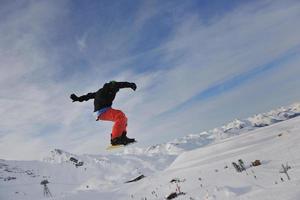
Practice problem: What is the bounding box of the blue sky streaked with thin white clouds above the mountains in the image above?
[0,0,300,159]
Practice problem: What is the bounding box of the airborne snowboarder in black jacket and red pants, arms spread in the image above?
[70,81,136,146]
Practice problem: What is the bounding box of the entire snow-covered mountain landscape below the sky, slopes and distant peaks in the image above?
[0,104,300,200]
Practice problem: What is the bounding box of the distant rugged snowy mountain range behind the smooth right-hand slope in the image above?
[139,103,300,155]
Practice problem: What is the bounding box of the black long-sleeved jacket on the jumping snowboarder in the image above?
[75,81,136,112]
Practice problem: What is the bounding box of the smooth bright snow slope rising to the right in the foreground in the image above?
[127,117,300,200]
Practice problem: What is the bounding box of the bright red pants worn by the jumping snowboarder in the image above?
[98,108,127,139]
